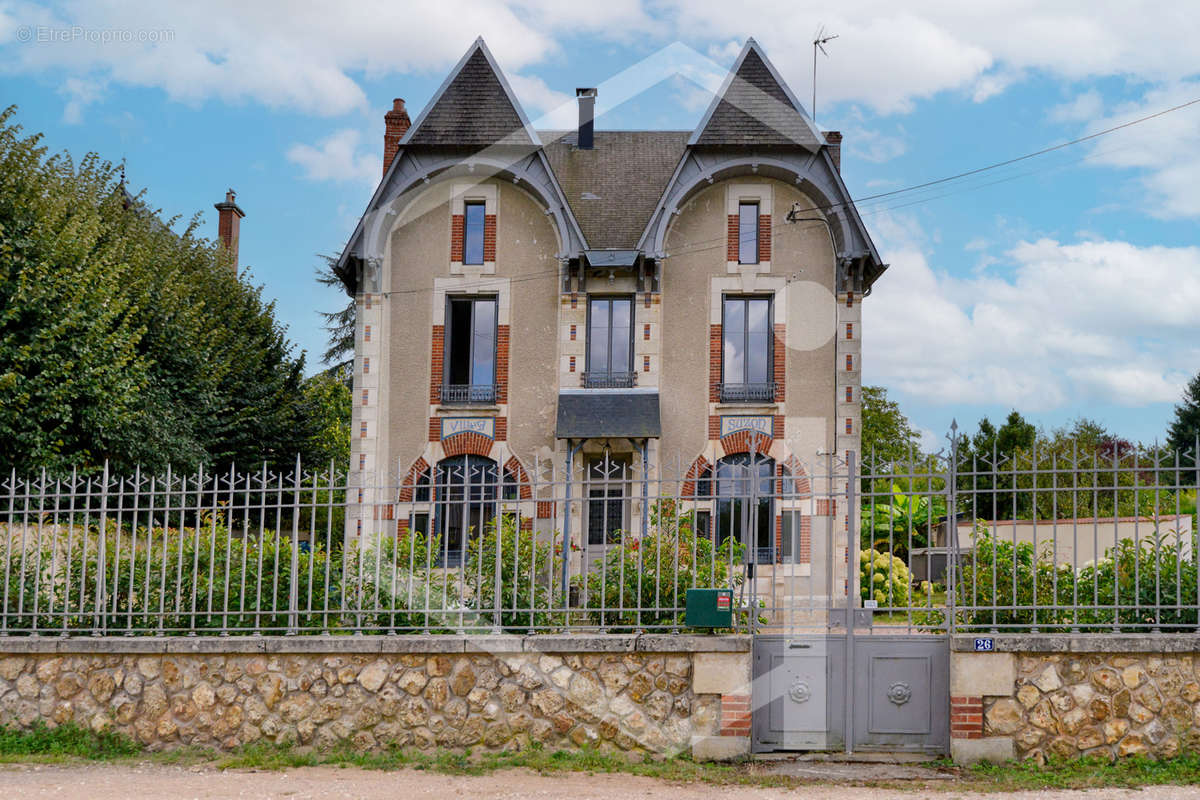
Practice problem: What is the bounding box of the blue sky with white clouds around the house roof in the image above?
[0,0,1200,449]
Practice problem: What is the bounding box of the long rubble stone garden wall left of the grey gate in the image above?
[0,636,750,758]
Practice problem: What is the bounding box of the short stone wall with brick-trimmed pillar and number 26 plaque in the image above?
[950,634,1200,762]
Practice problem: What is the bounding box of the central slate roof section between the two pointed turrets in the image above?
[539,131,691,249]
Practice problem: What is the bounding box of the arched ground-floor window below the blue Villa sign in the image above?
[436,455,499,566]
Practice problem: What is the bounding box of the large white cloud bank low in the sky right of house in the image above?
[864,212,1200,411]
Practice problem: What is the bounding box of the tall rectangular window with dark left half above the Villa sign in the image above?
[442,297,496,403]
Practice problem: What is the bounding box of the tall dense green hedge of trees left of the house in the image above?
[0,108,349,474]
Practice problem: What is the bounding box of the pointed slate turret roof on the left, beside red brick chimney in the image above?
[401,37,541,148]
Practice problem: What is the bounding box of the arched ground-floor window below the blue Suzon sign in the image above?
[713,453,775,563]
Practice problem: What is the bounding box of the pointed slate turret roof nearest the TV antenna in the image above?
[689,38,824,151]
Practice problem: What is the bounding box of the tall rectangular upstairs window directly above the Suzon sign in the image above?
[721,297,775,402]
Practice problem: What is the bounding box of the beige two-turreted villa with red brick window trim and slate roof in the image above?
[337,40,887,563]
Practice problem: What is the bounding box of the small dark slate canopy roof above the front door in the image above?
[554,389,662,439]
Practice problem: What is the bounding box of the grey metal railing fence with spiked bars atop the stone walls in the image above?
[0,435,1200,636]
